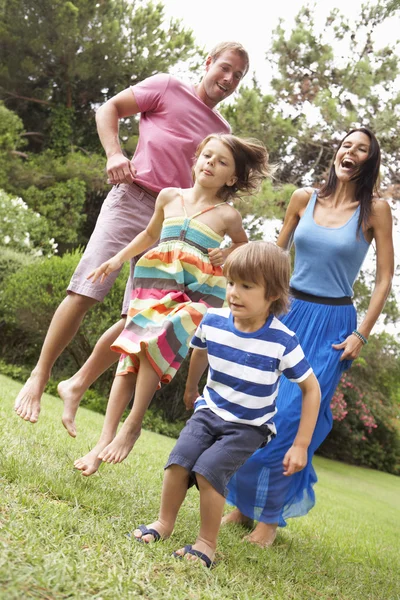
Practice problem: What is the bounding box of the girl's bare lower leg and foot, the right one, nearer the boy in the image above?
[99,352,160,463]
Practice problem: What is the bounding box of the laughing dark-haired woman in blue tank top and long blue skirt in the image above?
[224,128,394,546]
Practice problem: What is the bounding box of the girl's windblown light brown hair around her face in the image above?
[193,133,273,202]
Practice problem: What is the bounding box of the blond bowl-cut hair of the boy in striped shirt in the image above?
[223,242,290,316]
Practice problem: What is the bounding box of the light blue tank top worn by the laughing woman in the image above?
[290,190,369,298]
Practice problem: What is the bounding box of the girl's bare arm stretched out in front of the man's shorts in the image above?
[87,190,171,283]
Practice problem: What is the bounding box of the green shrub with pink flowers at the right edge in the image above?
[320,333,400,475]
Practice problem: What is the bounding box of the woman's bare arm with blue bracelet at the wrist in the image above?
[333,200,394,360]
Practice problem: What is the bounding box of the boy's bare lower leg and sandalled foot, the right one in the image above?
[176,473,225,562]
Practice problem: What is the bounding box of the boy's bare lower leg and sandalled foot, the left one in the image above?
[133,465,189,544]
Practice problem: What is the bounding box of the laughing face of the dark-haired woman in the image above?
[335,131,371,182]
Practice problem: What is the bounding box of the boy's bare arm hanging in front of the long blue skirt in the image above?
[283,373,321,475]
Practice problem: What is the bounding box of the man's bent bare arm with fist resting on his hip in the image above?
[96,88,140,185]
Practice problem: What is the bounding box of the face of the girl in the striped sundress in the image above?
[194,138,237,190]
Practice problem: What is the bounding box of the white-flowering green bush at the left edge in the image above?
[0,190,57,256]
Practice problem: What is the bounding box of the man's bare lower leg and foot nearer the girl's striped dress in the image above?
[57,319,125,437]
